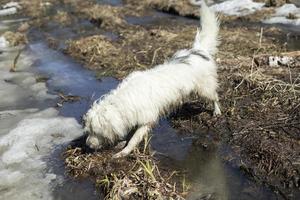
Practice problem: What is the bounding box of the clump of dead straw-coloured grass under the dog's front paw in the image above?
[64,141,188,200]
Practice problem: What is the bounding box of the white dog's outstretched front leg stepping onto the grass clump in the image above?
[113,125,150,158]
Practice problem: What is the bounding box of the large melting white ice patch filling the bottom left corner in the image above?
[0,108,82,200]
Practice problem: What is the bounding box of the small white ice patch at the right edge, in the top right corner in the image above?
[263,4,300,26]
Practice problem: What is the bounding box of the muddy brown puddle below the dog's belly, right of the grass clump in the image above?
[151,120,280,200]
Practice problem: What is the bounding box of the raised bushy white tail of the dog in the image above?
[193,0,219,55]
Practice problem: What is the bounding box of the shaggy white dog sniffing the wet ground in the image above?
[84,1,221,158]
